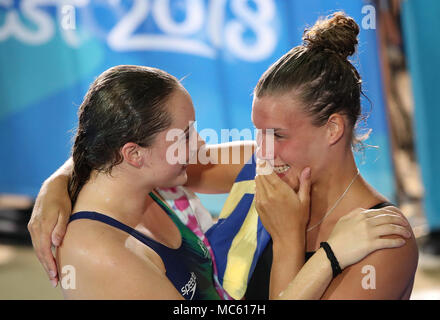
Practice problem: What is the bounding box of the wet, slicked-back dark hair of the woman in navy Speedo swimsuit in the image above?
[69,65,180,203]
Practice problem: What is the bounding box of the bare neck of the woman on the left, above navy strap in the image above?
[74,170,153,228]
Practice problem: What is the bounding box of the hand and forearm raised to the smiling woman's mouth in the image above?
[255,165,311,299]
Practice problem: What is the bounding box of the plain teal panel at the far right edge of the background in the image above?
[402,0,440,230]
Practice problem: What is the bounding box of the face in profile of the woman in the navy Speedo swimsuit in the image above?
[141,87,196,188]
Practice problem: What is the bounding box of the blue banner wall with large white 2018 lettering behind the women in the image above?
[0,0,394,215]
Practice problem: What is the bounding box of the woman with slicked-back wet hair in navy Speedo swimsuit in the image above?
[57,66,227,299]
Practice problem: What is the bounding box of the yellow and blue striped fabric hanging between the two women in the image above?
[205,155,270,300]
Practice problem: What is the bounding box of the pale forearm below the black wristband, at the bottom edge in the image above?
[277,248,333,300]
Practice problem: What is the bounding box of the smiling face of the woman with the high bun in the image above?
[252,94,329,190]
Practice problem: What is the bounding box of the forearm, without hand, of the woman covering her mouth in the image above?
[269,231,305,299]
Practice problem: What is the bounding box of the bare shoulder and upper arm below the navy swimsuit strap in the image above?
[57,221,180,299]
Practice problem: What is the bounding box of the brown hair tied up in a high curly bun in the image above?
[254,12,363,145]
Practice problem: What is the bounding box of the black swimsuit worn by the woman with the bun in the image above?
[245,202,394,300]
